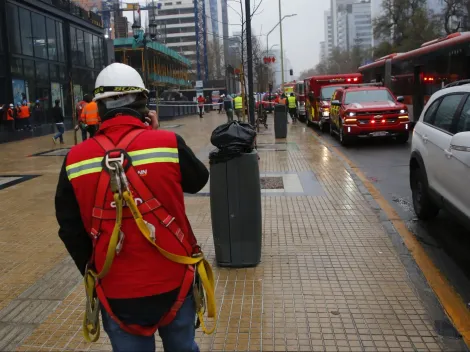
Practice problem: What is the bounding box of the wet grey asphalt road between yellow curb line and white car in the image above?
[312,127,470,308]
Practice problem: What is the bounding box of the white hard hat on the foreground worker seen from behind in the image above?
[93,63,148,101]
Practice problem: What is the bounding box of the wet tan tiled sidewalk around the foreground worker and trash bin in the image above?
[0,113,466,352]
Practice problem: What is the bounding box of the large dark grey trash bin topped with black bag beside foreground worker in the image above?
[210,122,262,268]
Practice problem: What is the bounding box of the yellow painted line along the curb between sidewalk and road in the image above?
[314,133,470,347]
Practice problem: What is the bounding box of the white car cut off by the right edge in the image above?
[410,80,470,227]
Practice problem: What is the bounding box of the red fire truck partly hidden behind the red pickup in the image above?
[304,73,362,132]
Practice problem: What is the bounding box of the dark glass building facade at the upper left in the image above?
[0,0,107,142]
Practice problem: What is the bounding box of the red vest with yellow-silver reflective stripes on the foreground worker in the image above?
[66,116,199,336]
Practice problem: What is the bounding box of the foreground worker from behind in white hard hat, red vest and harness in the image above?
[55,63,216,352]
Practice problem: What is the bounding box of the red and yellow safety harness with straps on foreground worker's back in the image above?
[83,129,216,342]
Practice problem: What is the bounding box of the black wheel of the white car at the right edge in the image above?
[411,167,439,220]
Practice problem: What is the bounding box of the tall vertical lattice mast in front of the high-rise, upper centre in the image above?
[194,0,209,81]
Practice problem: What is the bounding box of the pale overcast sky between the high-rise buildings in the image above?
[228,0,330,75]
